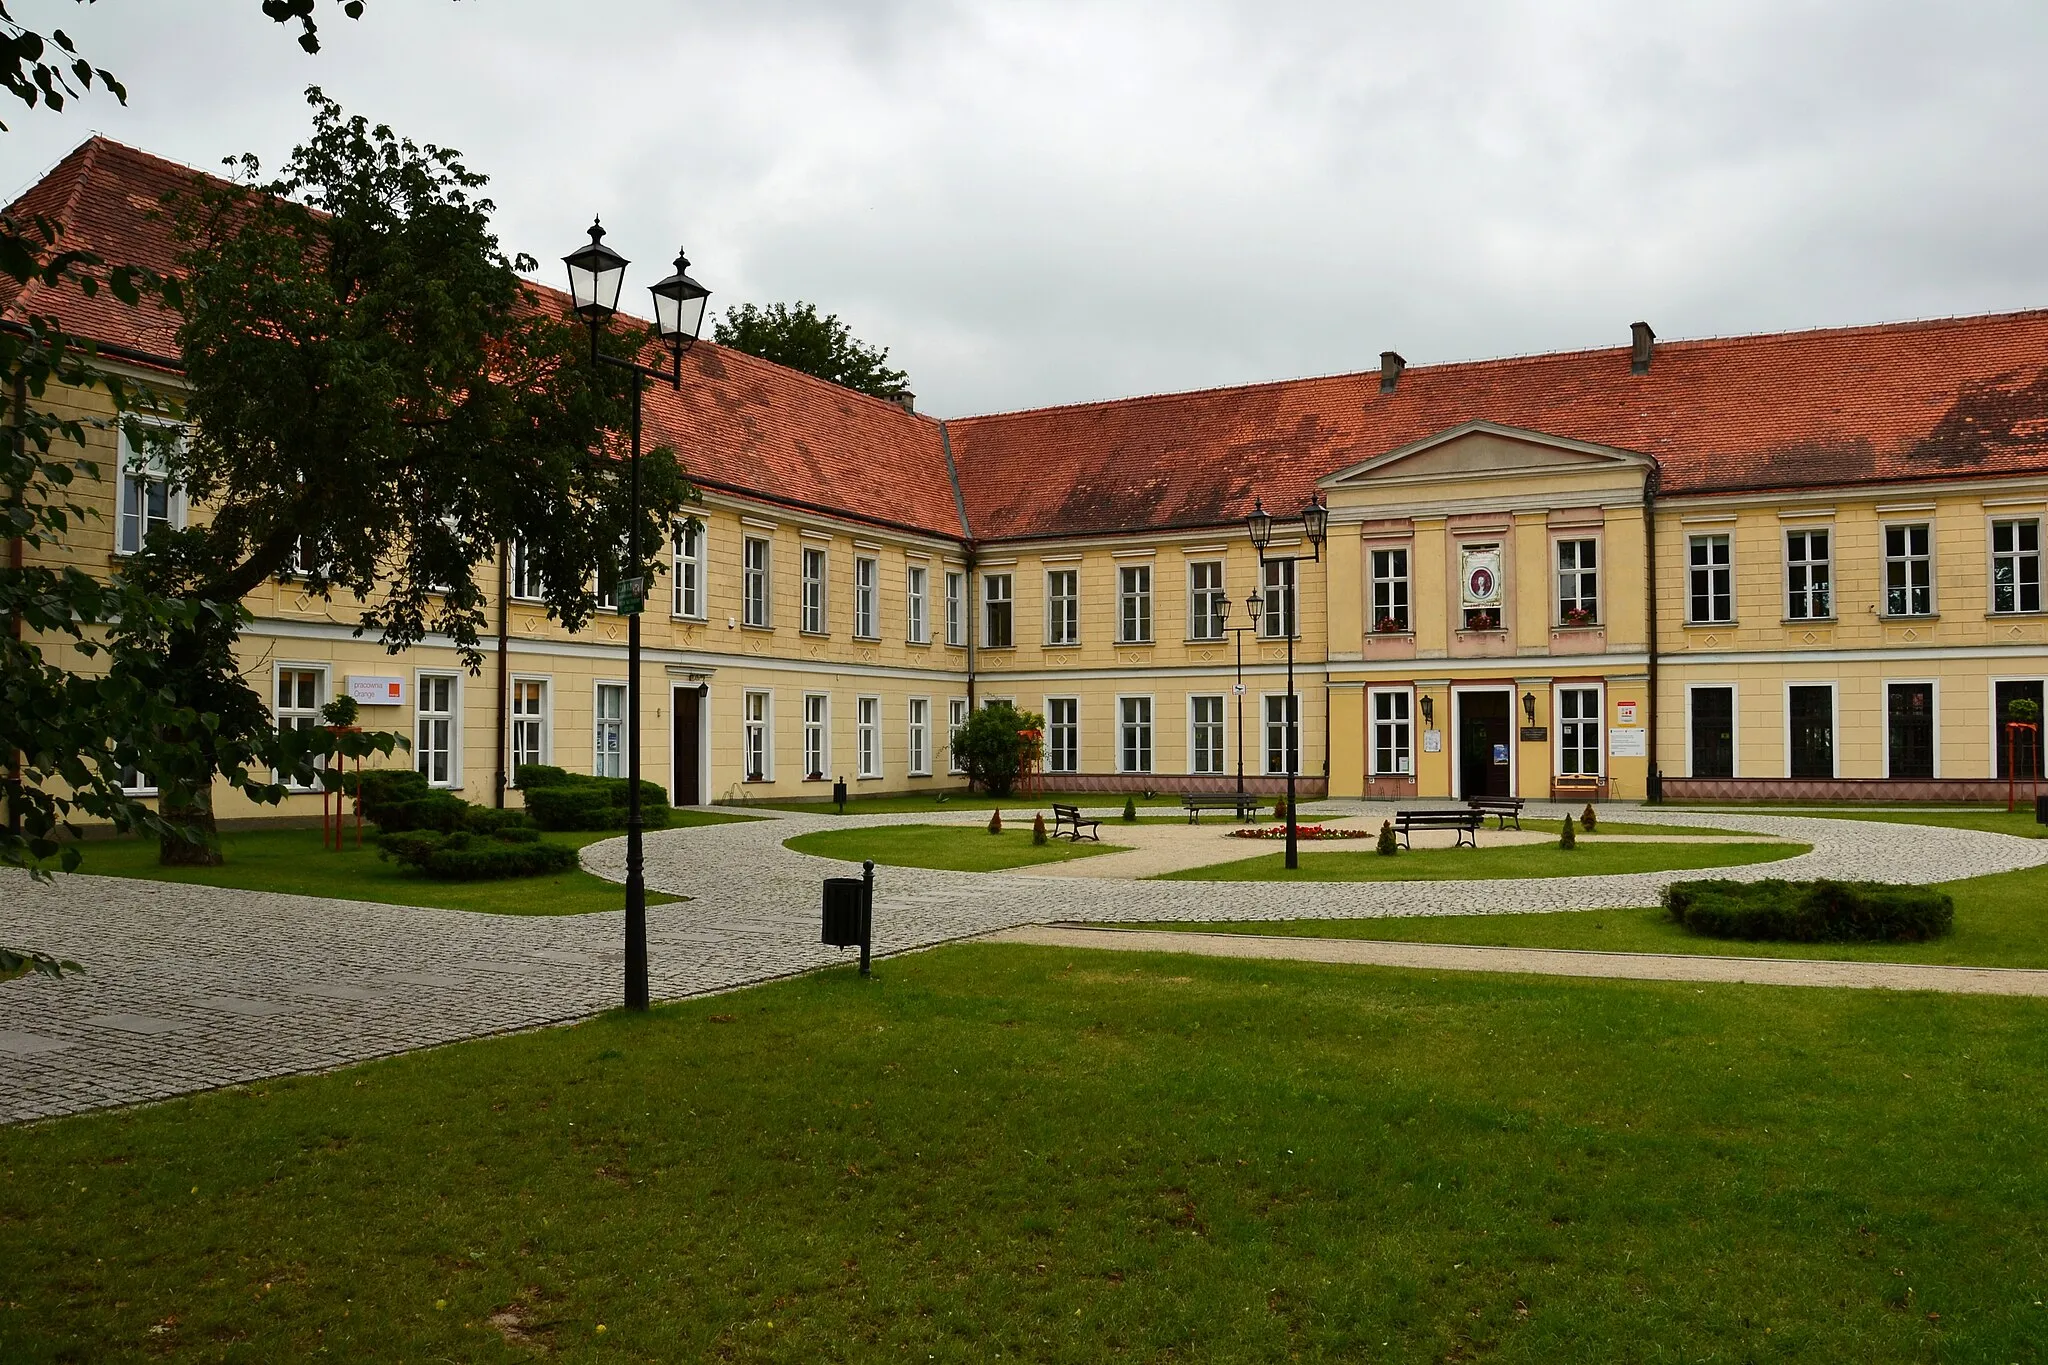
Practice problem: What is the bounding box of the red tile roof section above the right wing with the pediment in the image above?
[948,309,2048,540]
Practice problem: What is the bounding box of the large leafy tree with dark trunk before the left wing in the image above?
[137,88,692,862]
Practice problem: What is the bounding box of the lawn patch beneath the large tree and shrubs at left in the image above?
[59,810,757,915]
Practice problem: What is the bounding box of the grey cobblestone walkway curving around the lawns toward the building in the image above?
[0,802,2048,1121]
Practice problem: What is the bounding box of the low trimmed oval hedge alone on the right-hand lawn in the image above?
[1663,878,1956,943]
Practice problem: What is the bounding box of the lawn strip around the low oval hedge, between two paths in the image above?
[1155,860,2048,968]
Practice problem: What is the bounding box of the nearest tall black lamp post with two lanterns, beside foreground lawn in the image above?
[561,221,711,1009]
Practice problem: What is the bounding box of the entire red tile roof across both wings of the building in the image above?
[16,137,2048,540]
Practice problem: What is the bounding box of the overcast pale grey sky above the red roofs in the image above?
[0,0,2048,415]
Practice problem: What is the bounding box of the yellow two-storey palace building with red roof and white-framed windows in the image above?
[0,139,2048,817]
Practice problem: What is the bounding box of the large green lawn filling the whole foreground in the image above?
[0,945,2048,1365]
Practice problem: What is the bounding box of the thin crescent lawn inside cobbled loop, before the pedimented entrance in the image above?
[1151,835,1810,882]
